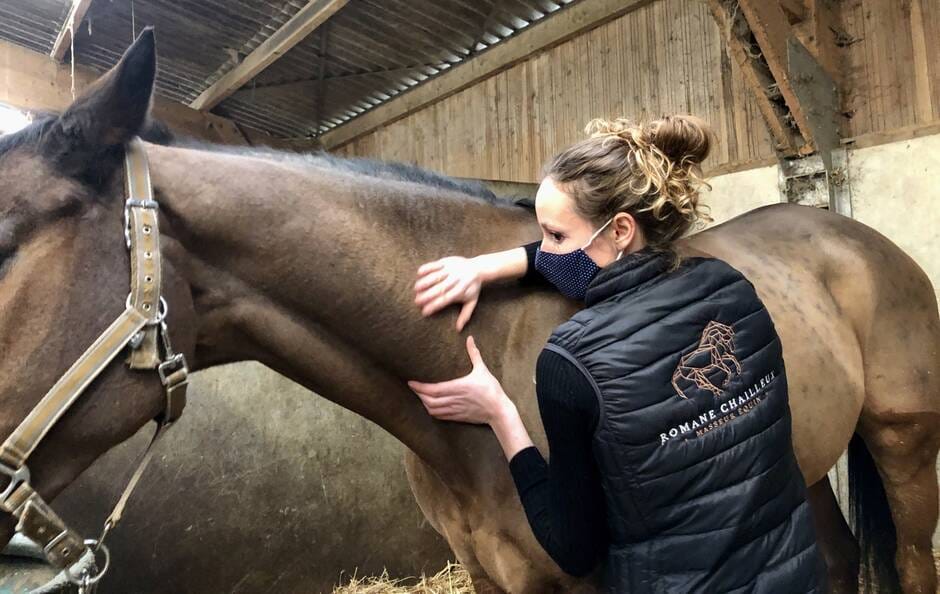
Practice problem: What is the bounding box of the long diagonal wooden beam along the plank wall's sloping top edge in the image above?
[320,0,655,150]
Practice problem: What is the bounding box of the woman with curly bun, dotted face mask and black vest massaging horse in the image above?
[409,116,825,594]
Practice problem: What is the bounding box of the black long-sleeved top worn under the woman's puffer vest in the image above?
[509,242,607,576]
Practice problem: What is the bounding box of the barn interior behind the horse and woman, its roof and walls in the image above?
[0,0,940,593]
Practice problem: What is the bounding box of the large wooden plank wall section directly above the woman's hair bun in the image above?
[337,0,773,182]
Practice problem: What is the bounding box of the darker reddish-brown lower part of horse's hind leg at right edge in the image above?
[860,412,940,594]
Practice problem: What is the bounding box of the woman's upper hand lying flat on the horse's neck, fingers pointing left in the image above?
[415,256,483,332]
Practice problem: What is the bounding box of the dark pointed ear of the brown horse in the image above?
[43,27,157,174]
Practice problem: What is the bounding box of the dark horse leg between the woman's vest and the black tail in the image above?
[807,476,859,594]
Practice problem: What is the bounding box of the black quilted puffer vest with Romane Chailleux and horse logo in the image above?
[546,250,825,594]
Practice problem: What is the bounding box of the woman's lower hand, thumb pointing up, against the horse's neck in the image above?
[408,336,512,425]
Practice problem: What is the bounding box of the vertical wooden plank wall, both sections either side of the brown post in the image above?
[337,0,940,182]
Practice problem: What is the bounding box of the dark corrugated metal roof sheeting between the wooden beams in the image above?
[0,0,576,138]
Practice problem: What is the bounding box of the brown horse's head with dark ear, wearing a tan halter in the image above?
[0,30,194,580]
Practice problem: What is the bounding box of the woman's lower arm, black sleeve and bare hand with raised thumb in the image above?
[408,337,607,576]
